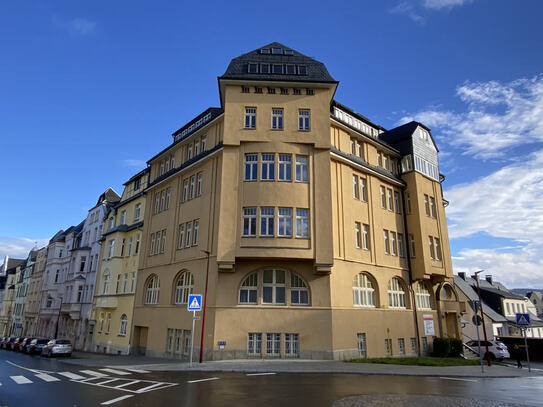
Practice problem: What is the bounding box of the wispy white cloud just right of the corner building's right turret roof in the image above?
[401,75,543,159]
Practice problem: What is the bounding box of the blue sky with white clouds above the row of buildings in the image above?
[0,0,543,288]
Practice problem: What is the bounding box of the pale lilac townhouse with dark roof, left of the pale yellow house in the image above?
[59,188,120,350]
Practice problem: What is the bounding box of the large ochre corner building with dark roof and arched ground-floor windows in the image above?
[132,43,461,359]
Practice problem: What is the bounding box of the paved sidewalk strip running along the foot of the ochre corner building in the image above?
[59,352,543,378]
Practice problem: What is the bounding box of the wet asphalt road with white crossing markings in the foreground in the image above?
[0,350,543,407]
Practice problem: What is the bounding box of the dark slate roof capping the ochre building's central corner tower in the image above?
[219,42,338,84]
